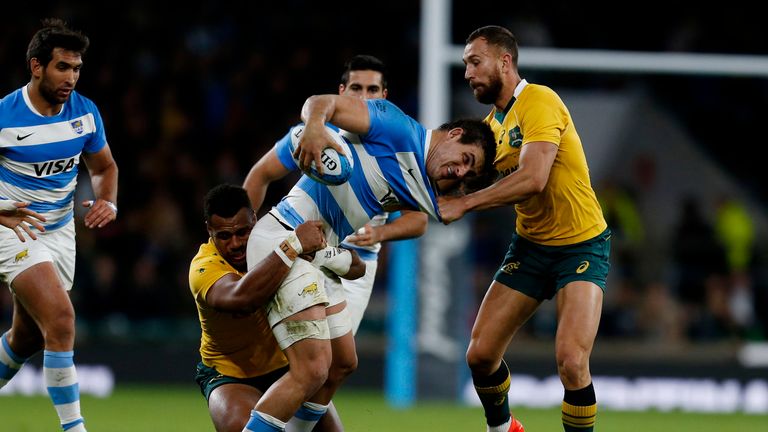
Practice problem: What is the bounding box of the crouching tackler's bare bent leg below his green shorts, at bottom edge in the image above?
[208,383,262,432]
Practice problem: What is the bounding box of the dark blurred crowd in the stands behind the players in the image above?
[0,0,768,354]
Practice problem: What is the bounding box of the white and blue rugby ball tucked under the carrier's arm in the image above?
[291,125,355,186]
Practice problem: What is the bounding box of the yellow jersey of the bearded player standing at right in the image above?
[485,80,607,246]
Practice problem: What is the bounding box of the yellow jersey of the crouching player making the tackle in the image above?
[189,239,288,378]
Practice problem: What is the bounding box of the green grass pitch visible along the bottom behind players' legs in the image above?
[0,386,768,432]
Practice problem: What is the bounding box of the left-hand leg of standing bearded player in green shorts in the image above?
[467,281,539,432]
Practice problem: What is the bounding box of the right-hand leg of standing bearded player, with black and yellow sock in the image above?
[555,281,603,432]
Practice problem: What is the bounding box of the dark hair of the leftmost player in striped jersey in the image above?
[27,18,91,72]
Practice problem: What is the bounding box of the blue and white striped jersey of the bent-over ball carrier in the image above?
[275,99,440,246]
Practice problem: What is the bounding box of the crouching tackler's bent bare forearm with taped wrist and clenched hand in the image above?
[205,221,326,312]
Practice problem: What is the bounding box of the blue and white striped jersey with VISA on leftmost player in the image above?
[0,86,107,231]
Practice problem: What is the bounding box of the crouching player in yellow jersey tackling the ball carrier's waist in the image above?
[189,185,365,432]
